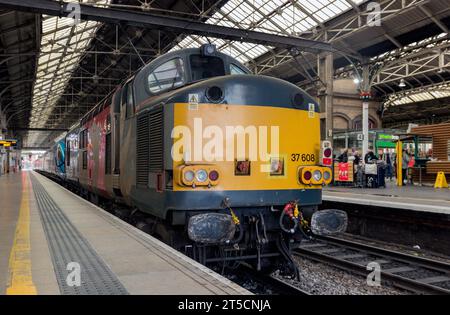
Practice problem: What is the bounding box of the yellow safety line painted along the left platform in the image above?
[6,172,37,295]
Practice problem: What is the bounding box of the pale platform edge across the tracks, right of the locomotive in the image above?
[322,181,450,214]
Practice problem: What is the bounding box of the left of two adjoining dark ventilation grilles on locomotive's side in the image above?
[136,113,150,186]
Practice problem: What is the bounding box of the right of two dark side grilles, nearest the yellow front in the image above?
[149,107,164,173]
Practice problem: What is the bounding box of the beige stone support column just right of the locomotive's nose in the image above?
[318,53,334,141]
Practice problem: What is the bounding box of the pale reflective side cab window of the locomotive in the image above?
[148,58,184,94]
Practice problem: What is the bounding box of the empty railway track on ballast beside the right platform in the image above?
[294,236,450,294]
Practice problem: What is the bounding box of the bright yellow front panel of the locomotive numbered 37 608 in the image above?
[173,103,331,194]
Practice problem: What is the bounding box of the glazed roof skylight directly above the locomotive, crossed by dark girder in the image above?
[172,0,356,63]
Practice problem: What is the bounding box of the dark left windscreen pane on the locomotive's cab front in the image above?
[189,55,225,81]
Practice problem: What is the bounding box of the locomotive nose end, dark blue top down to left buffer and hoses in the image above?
[167,76,346,270]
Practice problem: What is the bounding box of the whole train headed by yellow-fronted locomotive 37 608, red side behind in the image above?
[42,45,346,272]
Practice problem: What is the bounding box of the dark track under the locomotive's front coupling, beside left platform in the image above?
[235,264,311,295]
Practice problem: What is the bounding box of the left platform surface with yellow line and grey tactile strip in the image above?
[0,171,250,295]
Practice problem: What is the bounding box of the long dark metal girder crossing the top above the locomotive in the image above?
[0,0,334,53]
